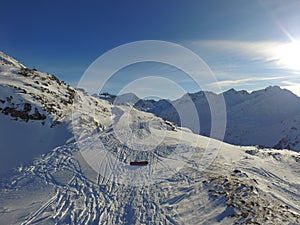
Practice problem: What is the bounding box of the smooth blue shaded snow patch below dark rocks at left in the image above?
[0,114,71,175]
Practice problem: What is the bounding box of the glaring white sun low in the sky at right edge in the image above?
[275,41,300,70]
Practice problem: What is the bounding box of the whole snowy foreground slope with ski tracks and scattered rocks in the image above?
[0,53,300,225]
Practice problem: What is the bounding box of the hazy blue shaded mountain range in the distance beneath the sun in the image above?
[136,86,300,151]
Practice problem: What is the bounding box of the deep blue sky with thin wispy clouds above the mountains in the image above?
[0,0,300,98]
